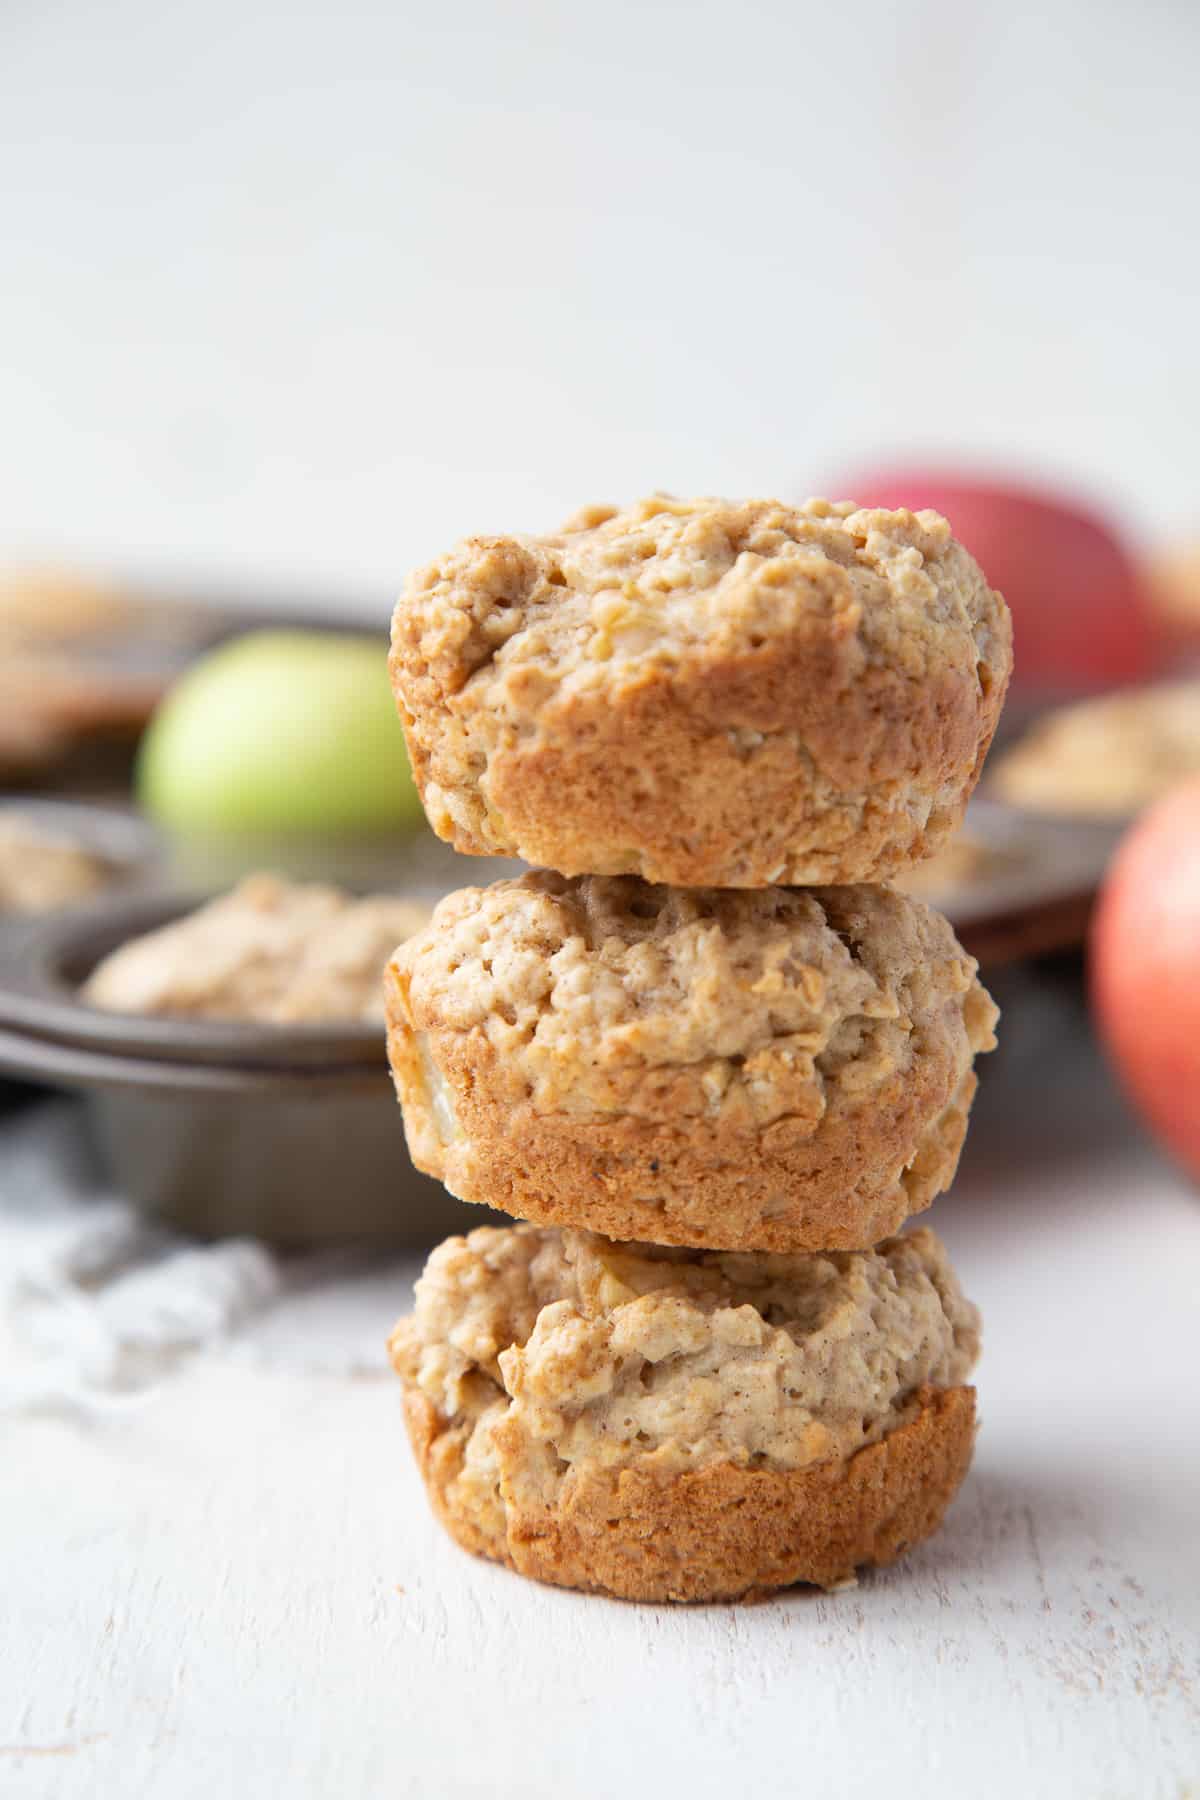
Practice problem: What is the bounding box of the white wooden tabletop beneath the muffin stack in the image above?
[0,972,1200,1800]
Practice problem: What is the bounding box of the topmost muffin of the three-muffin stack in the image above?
[390,495,1011,887]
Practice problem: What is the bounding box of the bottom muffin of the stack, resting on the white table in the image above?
[390,1226,979,1600]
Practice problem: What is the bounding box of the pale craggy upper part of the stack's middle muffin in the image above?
[396,871,997,1129]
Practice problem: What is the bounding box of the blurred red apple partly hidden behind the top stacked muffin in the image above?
[842,466,1155,691]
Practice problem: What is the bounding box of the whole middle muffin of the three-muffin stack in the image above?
[387,871,997,1251]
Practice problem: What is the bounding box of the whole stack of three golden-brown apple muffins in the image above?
[389,497,1011,1600]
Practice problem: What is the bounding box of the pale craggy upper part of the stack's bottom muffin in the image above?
[392,1226,979,1498]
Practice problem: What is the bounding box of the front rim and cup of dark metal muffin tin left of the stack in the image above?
[0,849,491,1246]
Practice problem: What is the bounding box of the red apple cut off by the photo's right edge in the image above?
[1090,779,1200,1179]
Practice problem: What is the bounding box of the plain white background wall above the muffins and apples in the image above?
[0,0,1200,610]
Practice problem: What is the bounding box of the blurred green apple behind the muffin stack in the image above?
[137,630,423,837]
